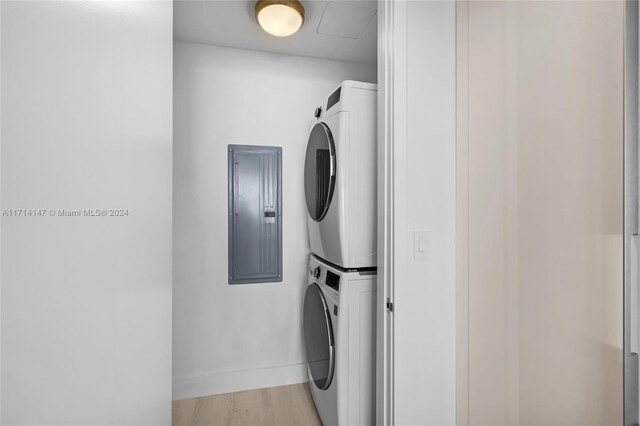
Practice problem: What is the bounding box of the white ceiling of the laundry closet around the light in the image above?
[173,0,377,64]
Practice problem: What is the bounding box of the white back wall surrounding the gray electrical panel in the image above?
[173,42,376,399]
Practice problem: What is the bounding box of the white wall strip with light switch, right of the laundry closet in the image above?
[378,1,456,426]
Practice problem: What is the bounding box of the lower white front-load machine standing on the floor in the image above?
[304,255,376,426]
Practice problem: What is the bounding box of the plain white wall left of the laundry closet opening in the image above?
[0,1,173,425]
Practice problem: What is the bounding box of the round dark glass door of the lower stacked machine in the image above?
[304,284,335,390]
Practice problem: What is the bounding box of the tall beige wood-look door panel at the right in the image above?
[458,1,624,425]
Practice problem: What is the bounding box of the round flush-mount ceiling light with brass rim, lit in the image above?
[256,0,304,37]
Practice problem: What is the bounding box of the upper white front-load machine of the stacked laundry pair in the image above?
[304,81,378,268]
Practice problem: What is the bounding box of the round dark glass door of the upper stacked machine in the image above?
[304,123,336,222]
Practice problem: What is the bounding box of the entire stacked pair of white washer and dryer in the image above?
[304,81,377,426]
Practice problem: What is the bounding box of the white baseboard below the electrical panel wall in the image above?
[173,363,307,400]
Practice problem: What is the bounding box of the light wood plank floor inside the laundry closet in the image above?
[172,383,322,426]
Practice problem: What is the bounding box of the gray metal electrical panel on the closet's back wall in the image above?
[228,145,282,284]
